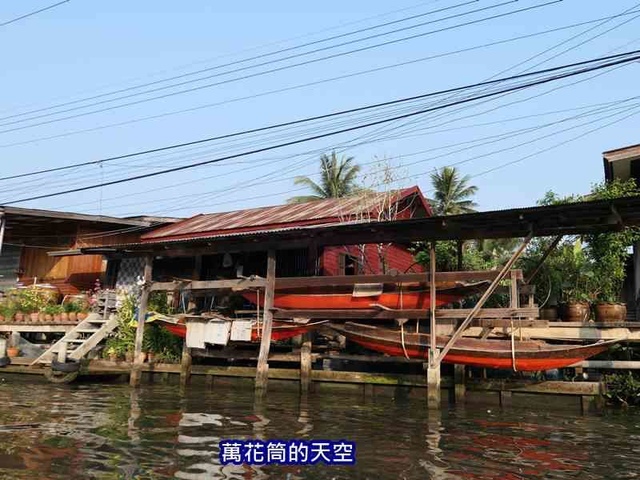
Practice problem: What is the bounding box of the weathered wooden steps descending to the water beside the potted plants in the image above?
[31,293,118,366]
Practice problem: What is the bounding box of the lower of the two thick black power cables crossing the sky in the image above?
[5,51,640,205]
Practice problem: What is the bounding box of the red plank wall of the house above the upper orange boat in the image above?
[320,244,424,275]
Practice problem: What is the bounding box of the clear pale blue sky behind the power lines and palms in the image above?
[0,0,640,217]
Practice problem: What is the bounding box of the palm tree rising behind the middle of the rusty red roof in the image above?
[287,151,360,203]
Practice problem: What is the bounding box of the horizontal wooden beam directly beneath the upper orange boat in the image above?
[273,307,540,320]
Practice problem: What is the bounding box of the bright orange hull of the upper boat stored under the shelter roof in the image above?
[242,282,484,310]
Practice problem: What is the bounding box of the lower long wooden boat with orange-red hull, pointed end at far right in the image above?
[331,322,620,371]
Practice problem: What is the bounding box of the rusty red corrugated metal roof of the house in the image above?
[141,186,431,243]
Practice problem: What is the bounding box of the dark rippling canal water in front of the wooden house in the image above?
[0,377,640,480]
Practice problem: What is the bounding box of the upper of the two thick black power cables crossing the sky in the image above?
[0,45,640,181]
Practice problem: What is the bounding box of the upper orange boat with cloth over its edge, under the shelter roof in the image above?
[242,282,487,310]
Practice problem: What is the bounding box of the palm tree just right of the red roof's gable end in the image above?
[429,167,478,215]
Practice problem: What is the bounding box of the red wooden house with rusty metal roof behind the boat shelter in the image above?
[118,186,431,285]
